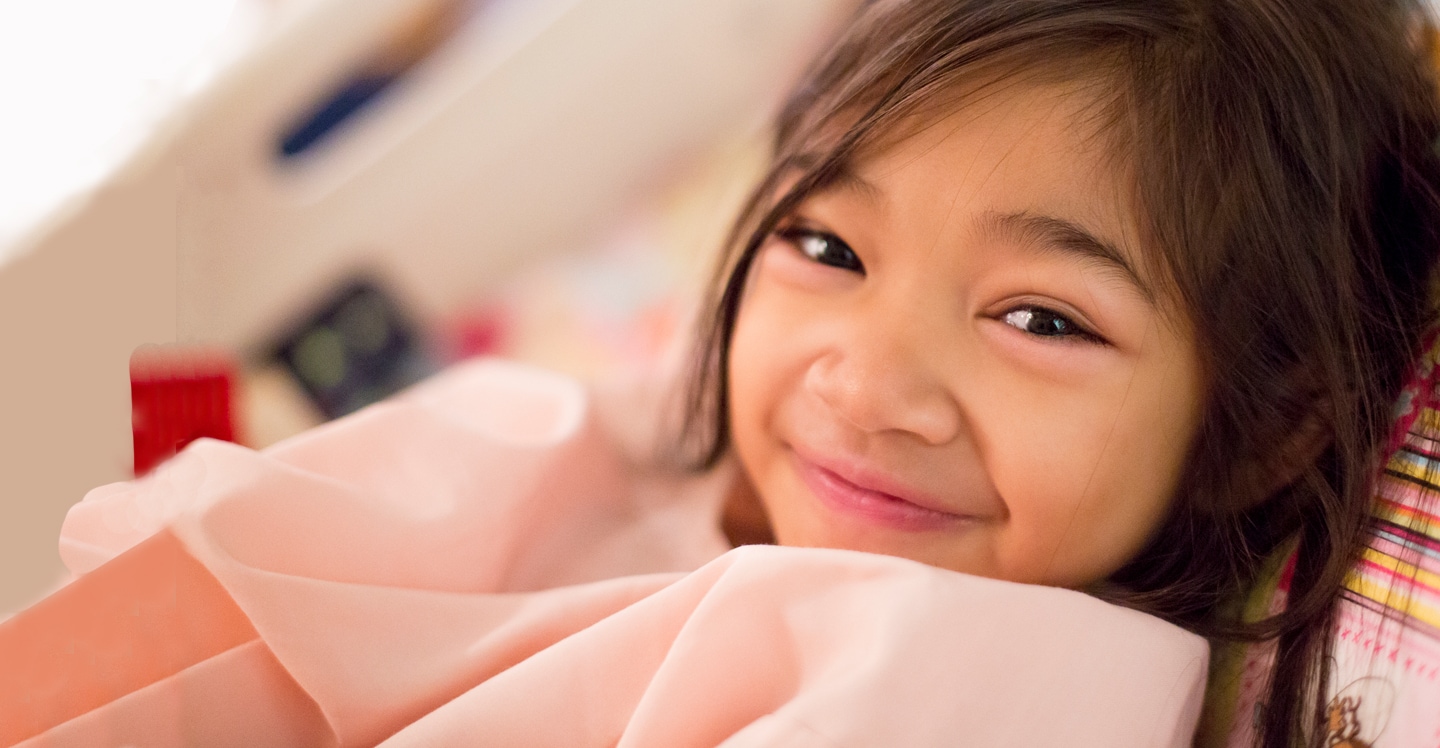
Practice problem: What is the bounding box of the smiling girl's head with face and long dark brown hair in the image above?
[676,0,1440,747]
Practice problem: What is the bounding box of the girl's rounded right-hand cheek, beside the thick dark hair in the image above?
[989,350,1198,587]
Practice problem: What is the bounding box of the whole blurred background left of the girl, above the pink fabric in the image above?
[0,0,855,618]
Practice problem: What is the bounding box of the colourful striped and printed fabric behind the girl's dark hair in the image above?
[1195,336,1440,748]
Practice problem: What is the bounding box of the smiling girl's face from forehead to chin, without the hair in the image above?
[729,85,1202,587]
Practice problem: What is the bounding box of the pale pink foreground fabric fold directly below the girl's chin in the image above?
[383,546,1207,748]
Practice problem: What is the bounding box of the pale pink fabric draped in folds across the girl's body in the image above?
[30,360,1208,748]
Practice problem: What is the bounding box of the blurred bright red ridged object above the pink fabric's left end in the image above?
[130,346,236,476]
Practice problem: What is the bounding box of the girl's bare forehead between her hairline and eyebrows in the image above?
[827,81,1188,321]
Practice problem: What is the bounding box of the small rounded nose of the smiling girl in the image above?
[805,317,963,445]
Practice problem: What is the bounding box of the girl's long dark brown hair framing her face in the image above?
[685,0,1440,747]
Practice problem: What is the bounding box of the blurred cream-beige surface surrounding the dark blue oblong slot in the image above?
[0,0,850,614]
